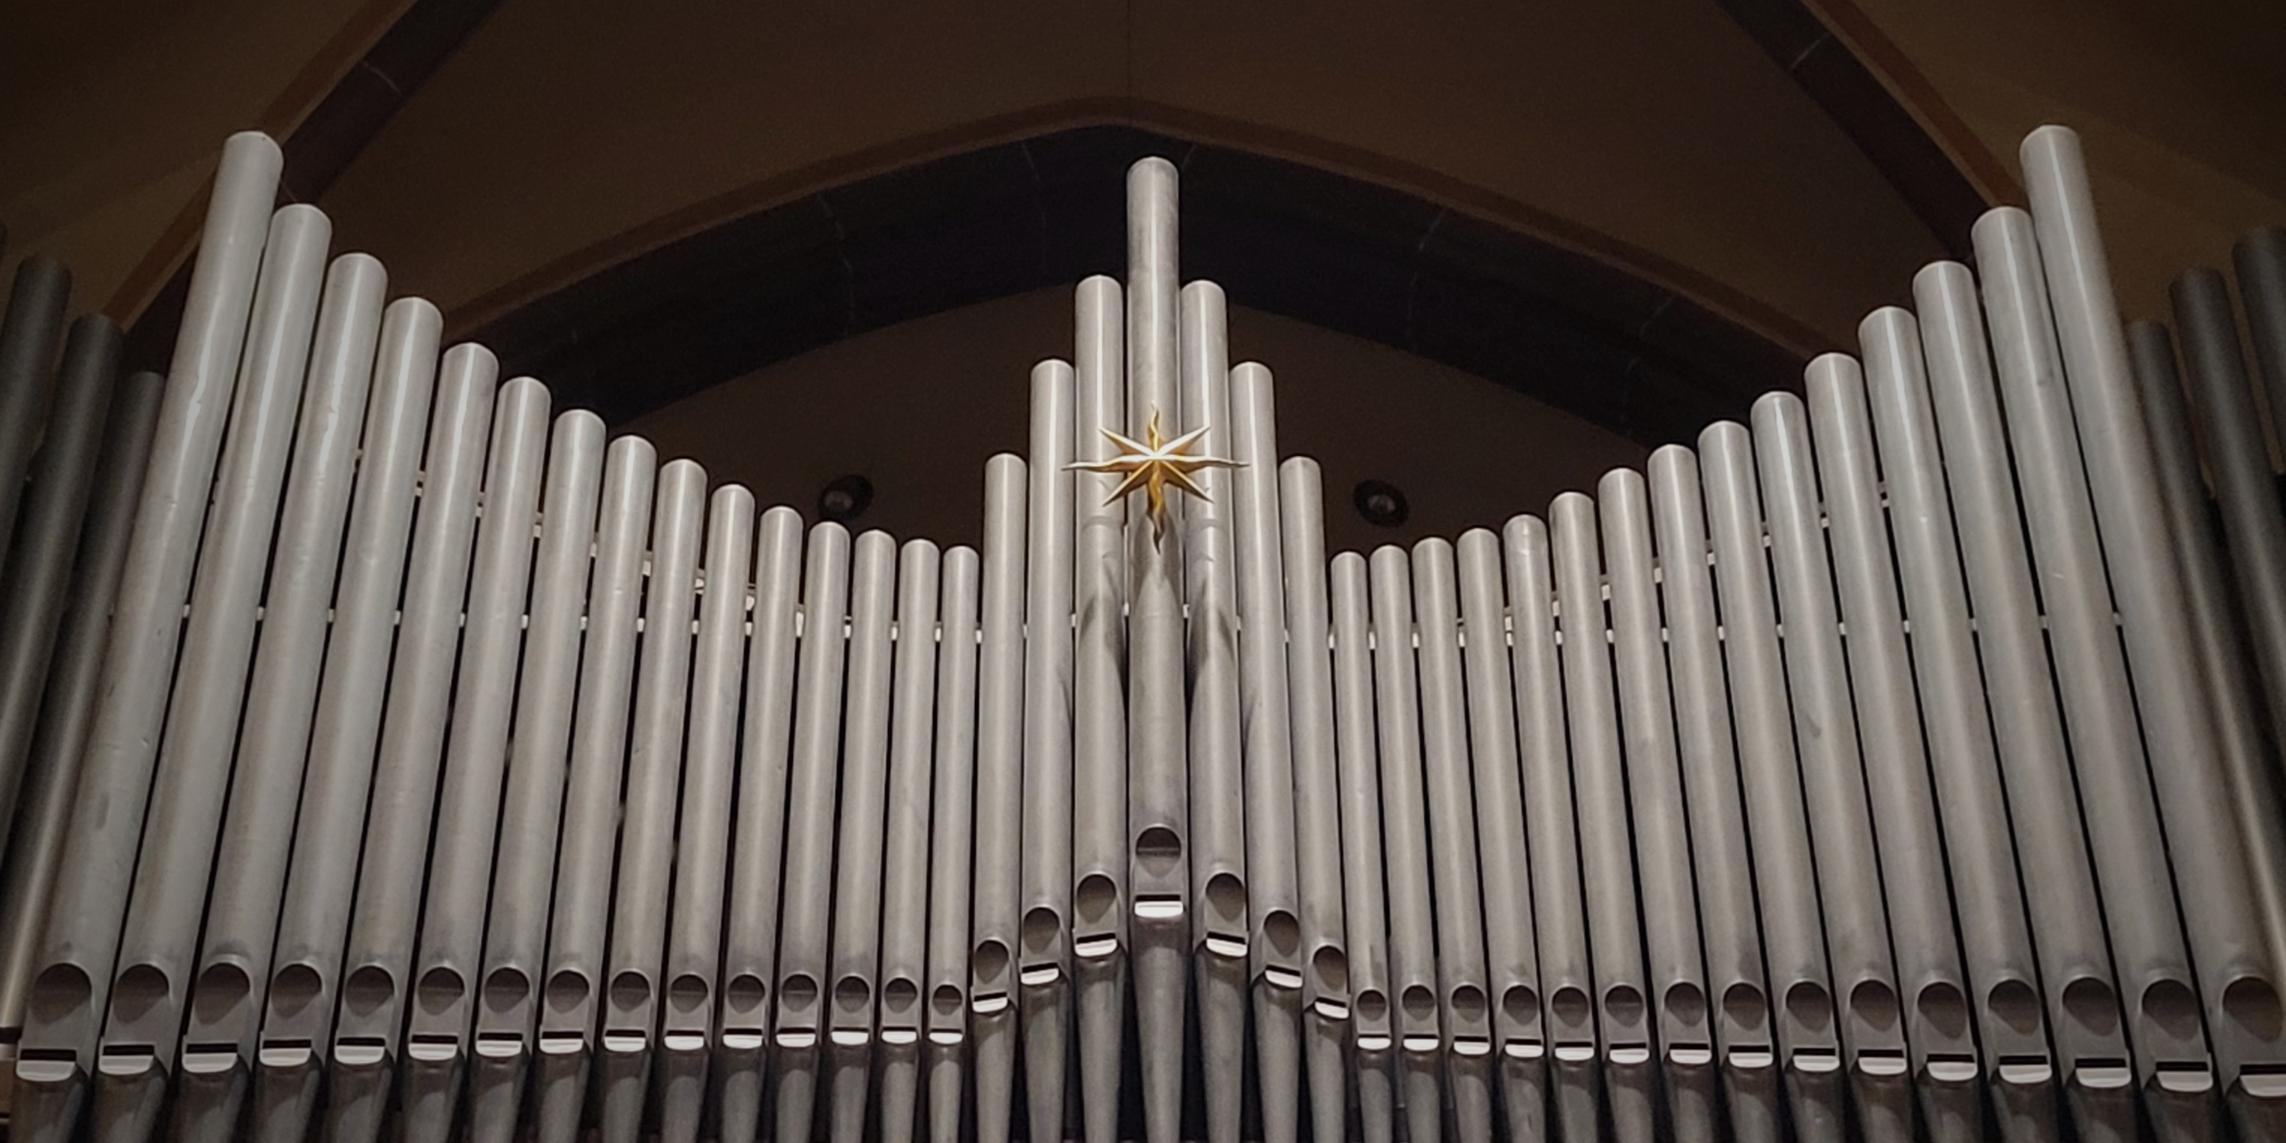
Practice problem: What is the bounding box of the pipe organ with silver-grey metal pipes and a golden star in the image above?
[0,128,2286,1143]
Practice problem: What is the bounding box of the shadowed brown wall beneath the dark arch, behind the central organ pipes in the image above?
[629,288,1644,551]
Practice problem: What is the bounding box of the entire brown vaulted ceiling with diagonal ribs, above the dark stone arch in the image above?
[0,0,2286,436]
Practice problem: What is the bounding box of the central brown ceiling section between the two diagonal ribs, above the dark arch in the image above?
[325,0,1936,347]
